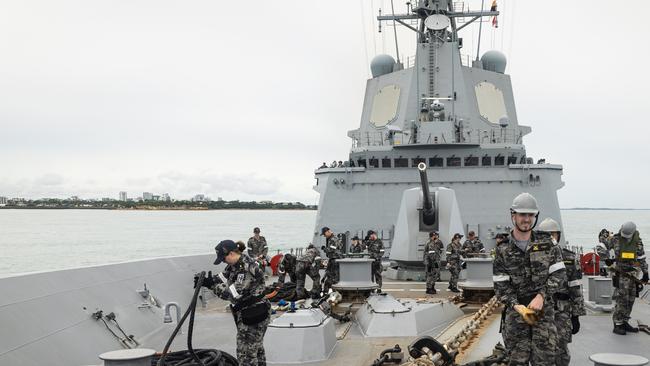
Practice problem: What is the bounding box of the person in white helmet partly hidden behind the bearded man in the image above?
[539,217,587,366]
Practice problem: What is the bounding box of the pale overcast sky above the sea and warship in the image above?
[0,0,650,208]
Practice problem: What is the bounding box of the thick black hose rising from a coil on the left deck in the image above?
[151,271,239,366]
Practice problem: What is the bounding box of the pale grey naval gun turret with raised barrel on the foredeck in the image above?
[386,163,464,280]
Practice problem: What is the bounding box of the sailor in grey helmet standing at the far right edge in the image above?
[606,221,648,335]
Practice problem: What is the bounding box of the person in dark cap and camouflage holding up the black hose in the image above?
[208,240,271,365]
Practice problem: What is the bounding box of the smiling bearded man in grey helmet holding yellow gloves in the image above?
[493,193,566,365]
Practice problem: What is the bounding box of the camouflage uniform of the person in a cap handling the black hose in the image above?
[215,254,271,365]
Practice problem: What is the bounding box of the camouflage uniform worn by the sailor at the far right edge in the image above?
[611,231,648,325]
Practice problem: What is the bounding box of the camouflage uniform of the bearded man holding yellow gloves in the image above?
[493,233,566,365]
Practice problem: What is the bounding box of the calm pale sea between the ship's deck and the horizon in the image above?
[0,210,650,277]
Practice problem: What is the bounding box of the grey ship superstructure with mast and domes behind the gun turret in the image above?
[314,0,564,255]
